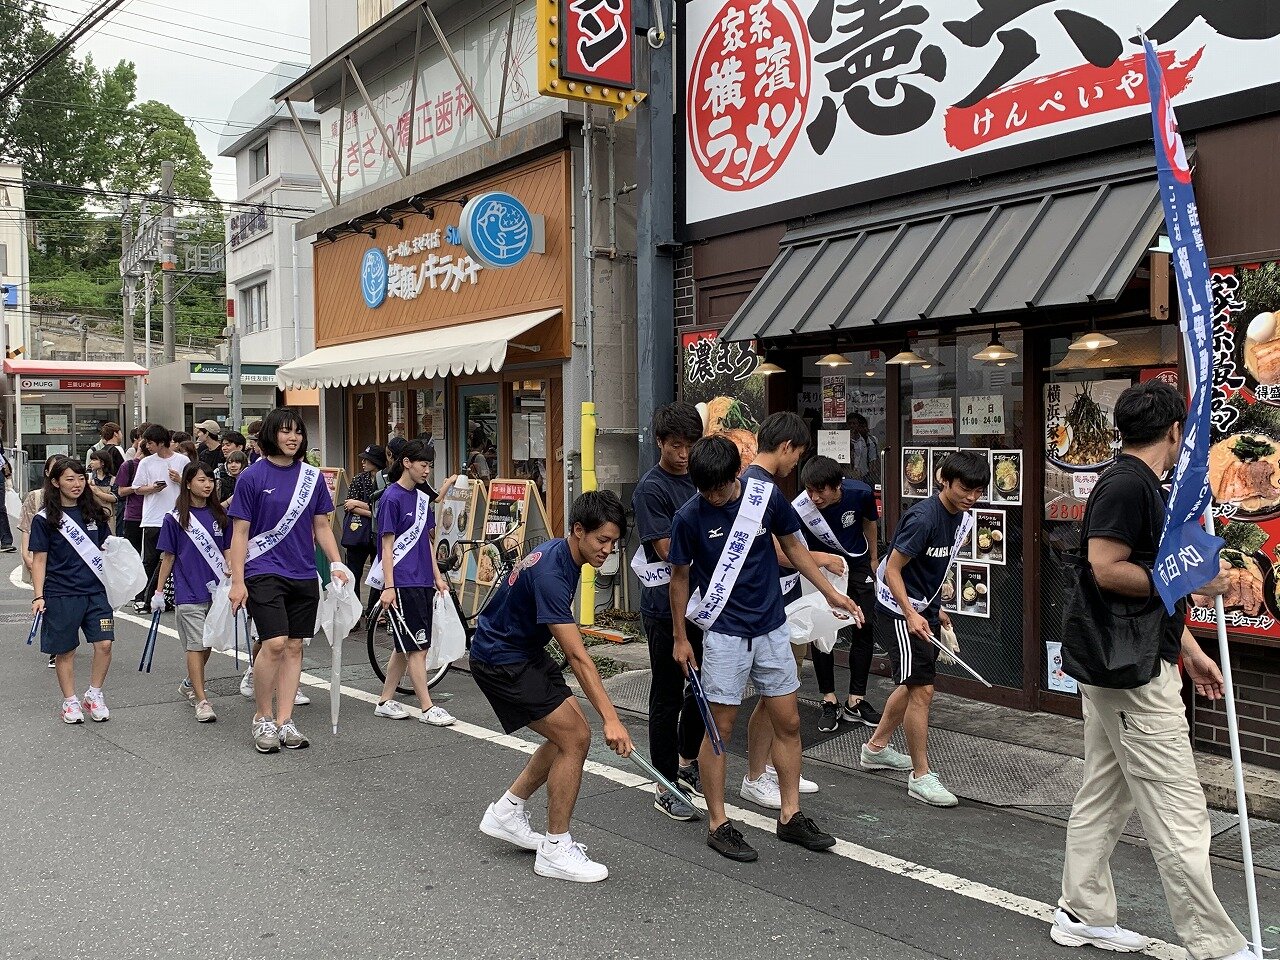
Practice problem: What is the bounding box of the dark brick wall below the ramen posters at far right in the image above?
[1196,641,1280,769]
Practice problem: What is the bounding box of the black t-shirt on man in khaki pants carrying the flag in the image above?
[1080,453,1187,663]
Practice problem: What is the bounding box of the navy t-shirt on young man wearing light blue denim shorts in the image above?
[667,467,800,637]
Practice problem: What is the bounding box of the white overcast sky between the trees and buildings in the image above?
[45,0,312,200]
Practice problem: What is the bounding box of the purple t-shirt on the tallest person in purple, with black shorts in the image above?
[227,457,333,580]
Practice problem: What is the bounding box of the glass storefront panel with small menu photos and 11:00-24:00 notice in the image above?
[901,333,1024,689]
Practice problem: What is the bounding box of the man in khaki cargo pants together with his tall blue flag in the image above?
[1050,38,1262,960]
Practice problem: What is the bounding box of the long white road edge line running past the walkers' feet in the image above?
[9,567,1187,960]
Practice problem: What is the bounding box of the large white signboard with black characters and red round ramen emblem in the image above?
[686,0,1280,231]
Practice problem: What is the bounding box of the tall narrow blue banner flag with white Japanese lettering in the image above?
[1142,37,1222,613]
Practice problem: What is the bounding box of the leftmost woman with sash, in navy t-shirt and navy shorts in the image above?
[29,457,115,723]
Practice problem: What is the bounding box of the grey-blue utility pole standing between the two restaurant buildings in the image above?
[634,0,676,474]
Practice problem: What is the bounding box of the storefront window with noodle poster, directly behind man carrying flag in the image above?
[1033,325,1179,694]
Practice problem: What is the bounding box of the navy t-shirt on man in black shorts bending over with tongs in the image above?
[471,540,579,666]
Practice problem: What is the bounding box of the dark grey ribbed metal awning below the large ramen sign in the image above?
[721,155,1164,340]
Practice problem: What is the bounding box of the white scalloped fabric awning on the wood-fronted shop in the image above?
[275,310,561,389]
